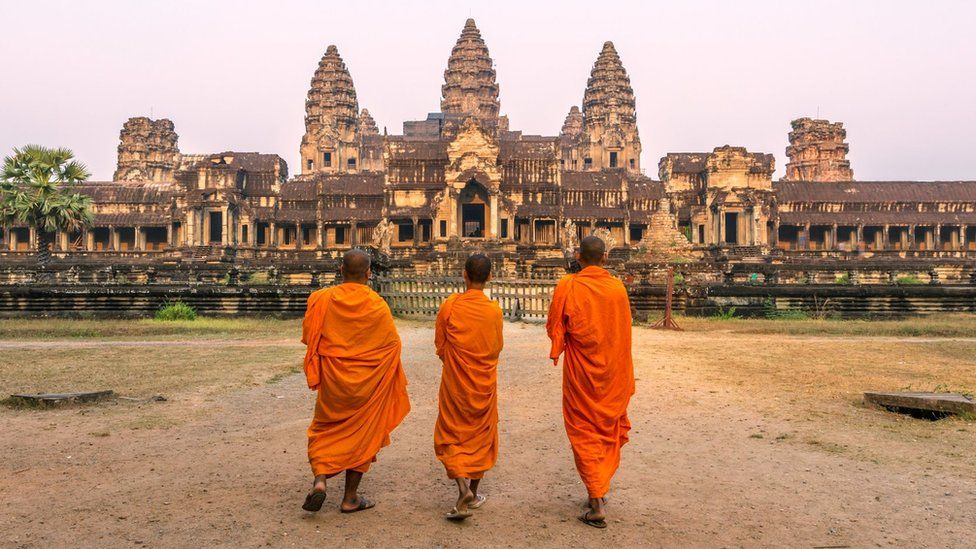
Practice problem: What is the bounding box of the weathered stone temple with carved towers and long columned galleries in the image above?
[0,19,976,277]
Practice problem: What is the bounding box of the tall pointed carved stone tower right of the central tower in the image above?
[579,42,641,172]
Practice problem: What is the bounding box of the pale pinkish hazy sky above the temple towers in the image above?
[0,0,976,180]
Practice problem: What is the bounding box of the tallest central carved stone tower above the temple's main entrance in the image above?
[441,19,499,131]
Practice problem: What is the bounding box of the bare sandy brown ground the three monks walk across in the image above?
[0,322,976,547]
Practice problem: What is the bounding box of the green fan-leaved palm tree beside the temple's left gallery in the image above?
[0,145,94,266]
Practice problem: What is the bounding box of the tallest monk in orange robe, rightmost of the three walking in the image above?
[546,236,634,528]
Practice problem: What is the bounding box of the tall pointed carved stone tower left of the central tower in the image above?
[300,46,360,175]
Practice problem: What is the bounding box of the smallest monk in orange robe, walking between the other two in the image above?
[434,254,502,521]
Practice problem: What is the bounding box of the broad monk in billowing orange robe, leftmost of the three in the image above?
[302,250,410,513]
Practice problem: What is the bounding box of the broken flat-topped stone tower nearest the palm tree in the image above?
[112,116,180,182]
